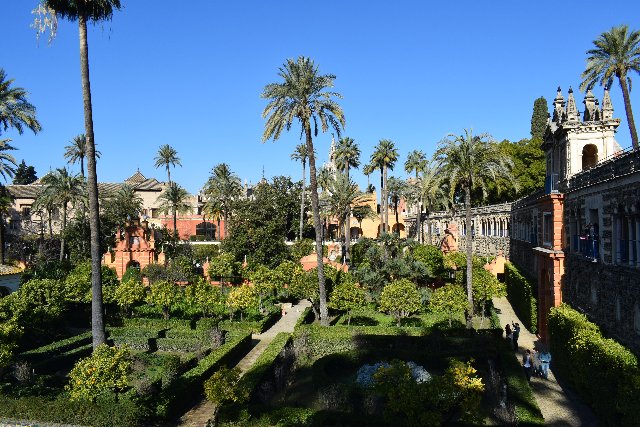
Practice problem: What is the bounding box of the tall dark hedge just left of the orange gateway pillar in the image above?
[504,262,538,334]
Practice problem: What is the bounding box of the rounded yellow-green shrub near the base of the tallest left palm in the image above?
[66,344,131,402]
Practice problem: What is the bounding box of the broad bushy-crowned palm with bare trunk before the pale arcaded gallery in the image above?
[434,129,515,328]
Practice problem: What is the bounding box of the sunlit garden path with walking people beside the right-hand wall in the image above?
[493,297,598,427]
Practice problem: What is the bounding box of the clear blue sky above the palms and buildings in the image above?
[0,0,640,192]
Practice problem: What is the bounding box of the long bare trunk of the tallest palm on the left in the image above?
[78,16,107,349]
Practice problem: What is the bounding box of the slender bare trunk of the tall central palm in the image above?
[304,122,329,326]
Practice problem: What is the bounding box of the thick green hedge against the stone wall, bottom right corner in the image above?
[548,304,640,426]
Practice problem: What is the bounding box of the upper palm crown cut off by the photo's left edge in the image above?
[0,68,42,135]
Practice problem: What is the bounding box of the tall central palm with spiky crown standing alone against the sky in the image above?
[262,56,345,326]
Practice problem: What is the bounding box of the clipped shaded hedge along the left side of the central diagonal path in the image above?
[157,333,251,418]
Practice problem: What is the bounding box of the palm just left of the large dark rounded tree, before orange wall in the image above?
[204,163,242,238]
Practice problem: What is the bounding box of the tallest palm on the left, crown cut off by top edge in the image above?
[41,0,121,349]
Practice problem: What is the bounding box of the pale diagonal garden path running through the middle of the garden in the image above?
[175,300,311,427]
